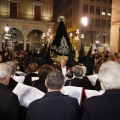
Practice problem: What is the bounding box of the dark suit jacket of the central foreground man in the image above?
[26,91,80,120]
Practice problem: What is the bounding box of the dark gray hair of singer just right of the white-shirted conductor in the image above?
[73,65,83,77]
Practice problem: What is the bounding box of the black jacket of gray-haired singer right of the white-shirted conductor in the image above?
[65,77,92,89]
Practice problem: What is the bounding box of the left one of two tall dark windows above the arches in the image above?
[10,2,17,18]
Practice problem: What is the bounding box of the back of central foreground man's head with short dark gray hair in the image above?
[46,70,64,90]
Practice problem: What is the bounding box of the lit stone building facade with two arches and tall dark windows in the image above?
[0,0,54,50]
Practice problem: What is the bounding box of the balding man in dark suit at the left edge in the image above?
[0,63,20,120]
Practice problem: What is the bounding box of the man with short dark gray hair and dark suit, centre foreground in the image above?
[26,71,80,120]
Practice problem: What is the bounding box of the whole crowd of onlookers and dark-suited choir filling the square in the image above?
[0,50,120,120]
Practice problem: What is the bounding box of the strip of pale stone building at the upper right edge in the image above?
[110,0,120,53]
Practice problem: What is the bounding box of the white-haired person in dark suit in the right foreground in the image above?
[82,61,120,120]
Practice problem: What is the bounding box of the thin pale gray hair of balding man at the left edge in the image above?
[0,63,11,81]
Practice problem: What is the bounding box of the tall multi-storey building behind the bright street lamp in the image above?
[53,0,112,51]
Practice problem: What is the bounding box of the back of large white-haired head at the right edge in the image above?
[98,61,120,90]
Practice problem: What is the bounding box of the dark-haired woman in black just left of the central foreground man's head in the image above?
[32,64,54,93]
